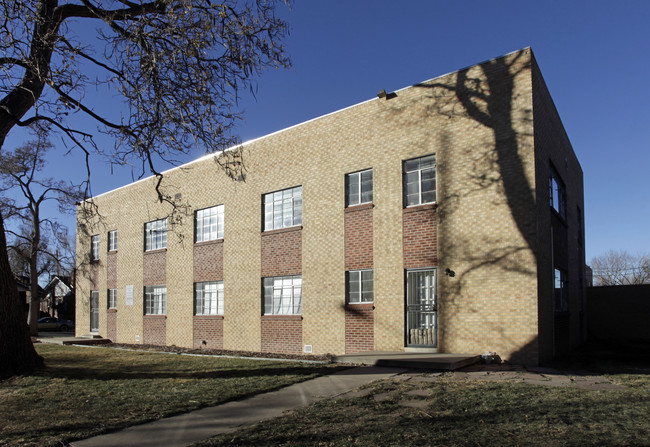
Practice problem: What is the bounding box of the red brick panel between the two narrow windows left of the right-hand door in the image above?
[345,204,373,270]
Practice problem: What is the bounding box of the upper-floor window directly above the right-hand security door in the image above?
[403,154,436,206]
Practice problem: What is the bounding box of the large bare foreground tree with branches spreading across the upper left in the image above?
[0,0,290,375]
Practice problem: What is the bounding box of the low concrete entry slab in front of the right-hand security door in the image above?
[332,351,481,371]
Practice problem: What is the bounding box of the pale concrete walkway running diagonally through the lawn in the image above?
[70,367,405,447]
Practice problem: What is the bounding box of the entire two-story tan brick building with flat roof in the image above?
[76,48,585,364]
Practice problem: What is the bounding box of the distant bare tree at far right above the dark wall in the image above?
[591,250,650,286]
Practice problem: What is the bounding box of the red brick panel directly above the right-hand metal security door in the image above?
[402,205,438,269]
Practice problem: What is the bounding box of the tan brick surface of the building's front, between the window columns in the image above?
[77,49,582,363]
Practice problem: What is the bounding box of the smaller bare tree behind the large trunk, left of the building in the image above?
[0,129,82,336]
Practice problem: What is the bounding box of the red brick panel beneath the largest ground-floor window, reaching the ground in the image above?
[261,315,302,354]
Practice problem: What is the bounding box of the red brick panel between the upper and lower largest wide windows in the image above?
[262,227,302,277]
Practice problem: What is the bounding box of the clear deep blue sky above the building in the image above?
[5,0,650,260]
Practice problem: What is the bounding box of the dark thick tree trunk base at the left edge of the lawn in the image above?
[0,216,43,379]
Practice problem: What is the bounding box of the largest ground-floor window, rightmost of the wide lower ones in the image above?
[264,275,302,315]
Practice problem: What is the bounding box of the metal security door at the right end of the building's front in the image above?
[406,269,438,348]
